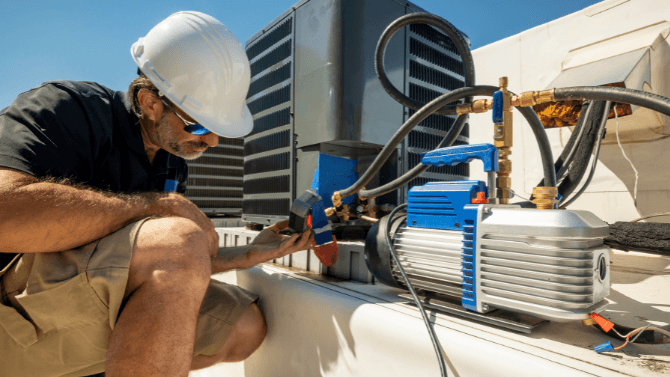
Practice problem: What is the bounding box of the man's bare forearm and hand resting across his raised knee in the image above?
[0,168,218,253]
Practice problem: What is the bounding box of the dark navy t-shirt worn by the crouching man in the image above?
[0,81,188,193]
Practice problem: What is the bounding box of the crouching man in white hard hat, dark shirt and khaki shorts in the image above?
[0,12,312,376]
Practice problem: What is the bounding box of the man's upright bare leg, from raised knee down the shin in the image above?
[106,217,211,377]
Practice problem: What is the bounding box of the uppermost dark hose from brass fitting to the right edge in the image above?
[554,86,670,116]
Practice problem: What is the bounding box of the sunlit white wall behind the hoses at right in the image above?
[470,0,670,223]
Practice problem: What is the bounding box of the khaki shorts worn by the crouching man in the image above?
[0,219,257,377]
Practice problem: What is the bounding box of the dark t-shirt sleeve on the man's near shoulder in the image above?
[0,83,99,182]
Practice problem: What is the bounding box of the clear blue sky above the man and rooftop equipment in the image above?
[0,0,598,108]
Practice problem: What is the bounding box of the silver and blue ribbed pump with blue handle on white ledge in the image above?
[365,144,610,322]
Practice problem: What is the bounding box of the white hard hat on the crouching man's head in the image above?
[130,12,253,137]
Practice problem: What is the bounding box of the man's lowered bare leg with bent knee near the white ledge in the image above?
[191,304,267,370]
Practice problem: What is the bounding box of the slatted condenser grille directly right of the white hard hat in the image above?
[242,15,295,223]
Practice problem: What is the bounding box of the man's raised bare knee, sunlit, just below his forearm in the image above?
[126,217,211,296]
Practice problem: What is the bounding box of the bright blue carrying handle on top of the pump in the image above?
[421,144,498,172]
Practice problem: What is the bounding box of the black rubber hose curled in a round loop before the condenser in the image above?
[375,13,475,115]
